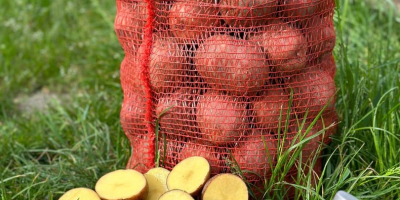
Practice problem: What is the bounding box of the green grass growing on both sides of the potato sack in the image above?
[0,0,400,200]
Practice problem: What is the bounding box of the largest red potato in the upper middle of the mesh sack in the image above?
[194,35,269,95]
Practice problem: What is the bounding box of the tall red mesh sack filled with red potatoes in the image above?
[115,0,337,190]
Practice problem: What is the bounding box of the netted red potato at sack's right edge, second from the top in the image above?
[305,16,336,57]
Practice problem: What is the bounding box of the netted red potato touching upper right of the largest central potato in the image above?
[262,21,307,72]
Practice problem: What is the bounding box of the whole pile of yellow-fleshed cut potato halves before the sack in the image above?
[59,156,249,200]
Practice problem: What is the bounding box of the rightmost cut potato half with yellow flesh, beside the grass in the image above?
[202,174,249,200]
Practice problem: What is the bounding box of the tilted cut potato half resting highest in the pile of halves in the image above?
[167,156,211,196]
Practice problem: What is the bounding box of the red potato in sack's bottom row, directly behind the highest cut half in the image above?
[178,142,224,174]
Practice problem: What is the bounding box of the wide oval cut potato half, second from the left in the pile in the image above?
[95,169,149,200]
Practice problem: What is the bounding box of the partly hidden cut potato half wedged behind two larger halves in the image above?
[144,167,169,200]
